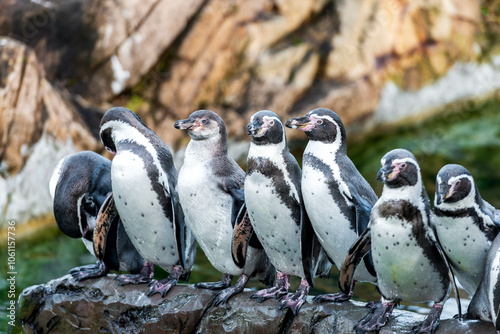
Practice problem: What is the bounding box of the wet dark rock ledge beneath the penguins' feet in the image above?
[16,275,495,334]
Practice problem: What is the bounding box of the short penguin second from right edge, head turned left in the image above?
[434,164,500,296]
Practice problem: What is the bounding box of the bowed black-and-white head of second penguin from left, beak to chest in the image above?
[99,107,147,154]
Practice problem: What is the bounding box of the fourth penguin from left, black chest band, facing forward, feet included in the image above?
[244,110,331,314]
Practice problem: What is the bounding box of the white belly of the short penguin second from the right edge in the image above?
[435,217,491,296]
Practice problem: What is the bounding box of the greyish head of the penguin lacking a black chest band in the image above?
[174,110,226,140]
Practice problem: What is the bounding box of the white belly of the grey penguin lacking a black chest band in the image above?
[178,164,243,275]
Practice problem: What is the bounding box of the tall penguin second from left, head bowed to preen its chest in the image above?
[99,108,196,296]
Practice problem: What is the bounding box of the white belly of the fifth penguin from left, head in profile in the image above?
[302,165,375,282]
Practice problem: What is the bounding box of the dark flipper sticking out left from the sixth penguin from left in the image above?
[339,226,371,294]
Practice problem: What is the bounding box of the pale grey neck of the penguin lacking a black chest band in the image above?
[184,136,227,164]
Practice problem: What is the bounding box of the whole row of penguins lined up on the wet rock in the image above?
[49,107,500,333]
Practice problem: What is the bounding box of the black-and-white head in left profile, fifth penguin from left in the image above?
[286,108,346,146]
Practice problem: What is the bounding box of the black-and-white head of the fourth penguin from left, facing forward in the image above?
[247,110,286,145]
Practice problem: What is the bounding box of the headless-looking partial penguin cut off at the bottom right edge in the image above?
[465,231,500,334]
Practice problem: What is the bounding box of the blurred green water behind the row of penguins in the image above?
[0,99,500,332]
